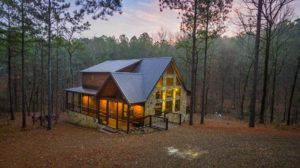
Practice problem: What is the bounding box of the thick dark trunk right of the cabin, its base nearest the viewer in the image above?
[249,0,263,127]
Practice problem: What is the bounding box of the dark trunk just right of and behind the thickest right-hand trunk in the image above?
[259,24,272,124]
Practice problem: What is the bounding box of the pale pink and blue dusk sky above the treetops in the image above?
[75,0,300,38]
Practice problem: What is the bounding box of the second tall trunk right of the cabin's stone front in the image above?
[200,2,209,124]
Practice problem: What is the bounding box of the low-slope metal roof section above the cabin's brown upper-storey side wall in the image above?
[81,59,140,72]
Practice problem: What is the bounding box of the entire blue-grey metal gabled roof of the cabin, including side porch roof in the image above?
[66,57,185,104]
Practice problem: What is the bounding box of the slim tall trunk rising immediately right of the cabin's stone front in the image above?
[189,0,198,125]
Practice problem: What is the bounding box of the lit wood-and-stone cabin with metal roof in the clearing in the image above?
[65,57,188,133]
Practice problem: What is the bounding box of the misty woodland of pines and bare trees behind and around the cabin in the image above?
[0,0,300,129]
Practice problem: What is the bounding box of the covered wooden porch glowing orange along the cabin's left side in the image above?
[66,87,145,133]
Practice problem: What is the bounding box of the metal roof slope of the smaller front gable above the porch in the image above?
[111,72,146,104]
